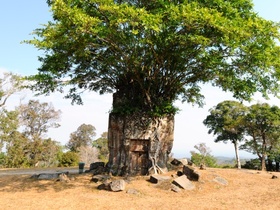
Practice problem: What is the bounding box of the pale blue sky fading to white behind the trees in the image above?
[0,0,280,157]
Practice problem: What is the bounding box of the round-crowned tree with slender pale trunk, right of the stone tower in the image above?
[203,101,247,169]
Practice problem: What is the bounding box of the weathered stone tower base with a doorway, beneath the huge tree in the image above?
[107,95,174,176]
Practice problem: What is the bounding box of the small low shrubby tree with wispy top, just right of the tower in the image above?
[191,143,217,167]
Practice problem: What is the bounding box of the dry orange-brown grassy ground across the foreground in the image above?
[0,169,280,210]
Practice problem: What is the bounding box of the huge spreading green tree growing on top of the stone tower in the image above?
[27,0,280,174]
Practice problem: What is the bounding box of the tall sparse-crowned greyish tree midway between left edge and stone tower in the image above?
[17,100,61,166]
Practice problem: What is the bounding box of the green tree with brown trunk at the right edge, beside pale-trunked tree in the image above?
[241,103,280,170]
